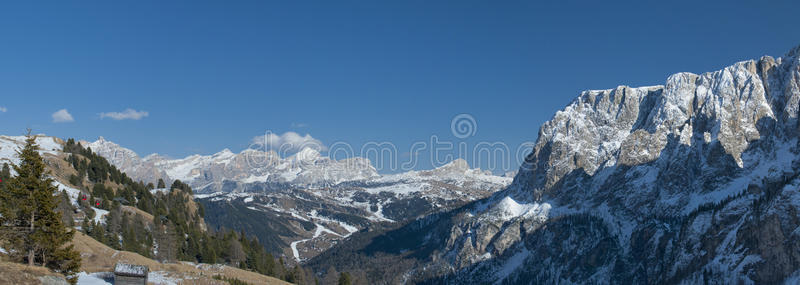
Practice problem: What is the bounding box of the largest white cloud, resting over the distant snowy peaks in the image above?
[250,132,328,155]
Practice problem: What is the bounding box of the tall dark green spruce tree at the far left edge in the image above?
[0,132,81,283]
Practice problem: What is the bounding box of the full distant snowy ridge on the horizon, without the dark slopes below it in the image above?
[80,137,510,194]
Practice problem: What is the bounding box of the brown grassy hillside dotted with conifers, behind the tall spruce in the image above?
[0,137,304,281]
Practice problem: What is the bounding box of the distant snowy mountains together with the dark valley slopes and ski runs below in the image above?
[81,137,512,262]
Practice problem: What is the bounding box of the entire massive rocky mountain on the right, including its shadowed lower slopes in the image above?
[310,47,800,284]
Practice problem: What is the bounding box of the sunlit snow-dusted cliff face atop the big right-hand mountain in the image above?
[518,53,800,195]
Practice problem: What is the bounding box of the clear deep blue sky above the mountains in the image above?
[0,1,800,172]
